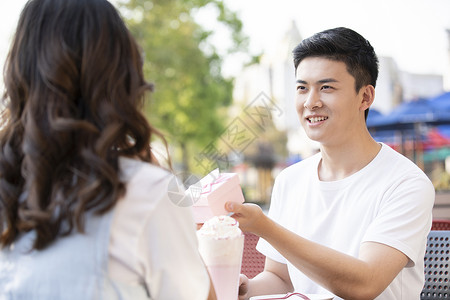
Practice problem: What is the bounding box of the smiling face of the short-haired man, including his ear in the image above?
[296,57,366,146]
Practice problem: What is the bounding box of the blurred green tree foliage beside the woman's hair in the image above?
[119,0,247,171]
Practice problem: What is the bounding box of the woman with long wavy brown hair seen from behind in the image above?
[0,0,215,300]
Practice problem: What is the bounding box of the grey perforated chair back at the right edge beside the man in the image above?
[420,230,450,300]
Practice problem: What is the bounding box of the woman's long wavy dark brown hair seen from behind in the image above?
[0,0,159,249]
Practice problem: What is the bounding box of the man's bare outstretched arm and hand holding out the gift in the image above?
[226,203,408,299]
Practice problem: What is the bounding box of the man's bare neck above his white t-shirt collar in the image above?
[318,136,381,181]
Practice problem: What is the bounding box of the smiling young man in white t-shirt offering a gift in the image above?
[226,28,434,300]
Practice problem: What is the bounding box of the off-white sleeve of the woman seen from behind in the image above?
[139,191,210,300]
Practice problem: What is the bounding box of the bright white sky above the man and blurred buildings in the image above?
[0,0,450,87]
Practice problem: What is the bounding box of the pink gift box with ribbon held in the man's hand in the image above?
[191,171,245,223]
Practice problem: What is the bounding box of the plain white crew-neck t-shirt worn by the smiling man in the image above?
[257,144,435,300]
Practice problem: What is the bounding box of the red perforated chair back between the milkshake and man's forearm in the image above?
[241,232,266,278]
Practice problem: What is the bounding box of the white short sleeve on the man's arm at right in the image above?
[362,174,435,267]
